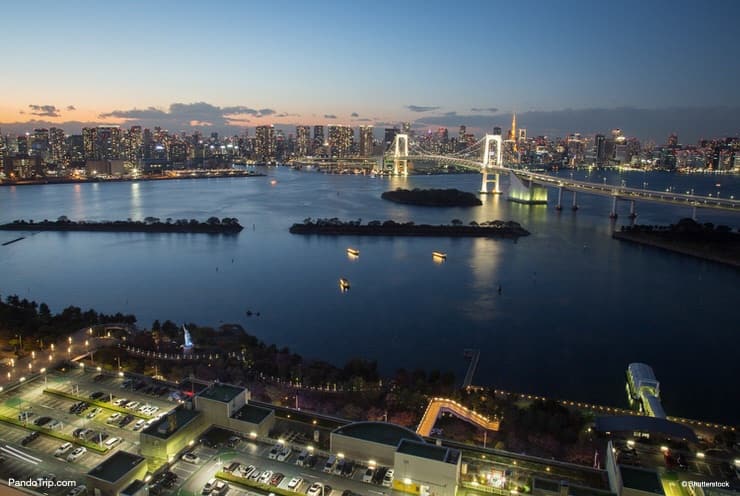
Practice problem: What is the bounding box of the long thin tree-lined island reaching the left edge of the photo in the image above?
[0,215,244,234]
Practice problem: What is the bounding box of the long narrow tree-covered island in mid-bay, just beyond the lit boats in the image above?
[290,217,529,238]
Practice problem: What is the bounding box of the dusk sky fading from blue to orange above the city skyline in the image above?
[0,0,740,139]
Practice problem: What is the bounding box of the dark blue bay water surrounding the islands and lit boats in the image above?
[0,168,740,421]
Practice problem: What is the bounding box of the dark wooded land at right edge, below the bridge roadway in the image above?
[612,218,740,268]
